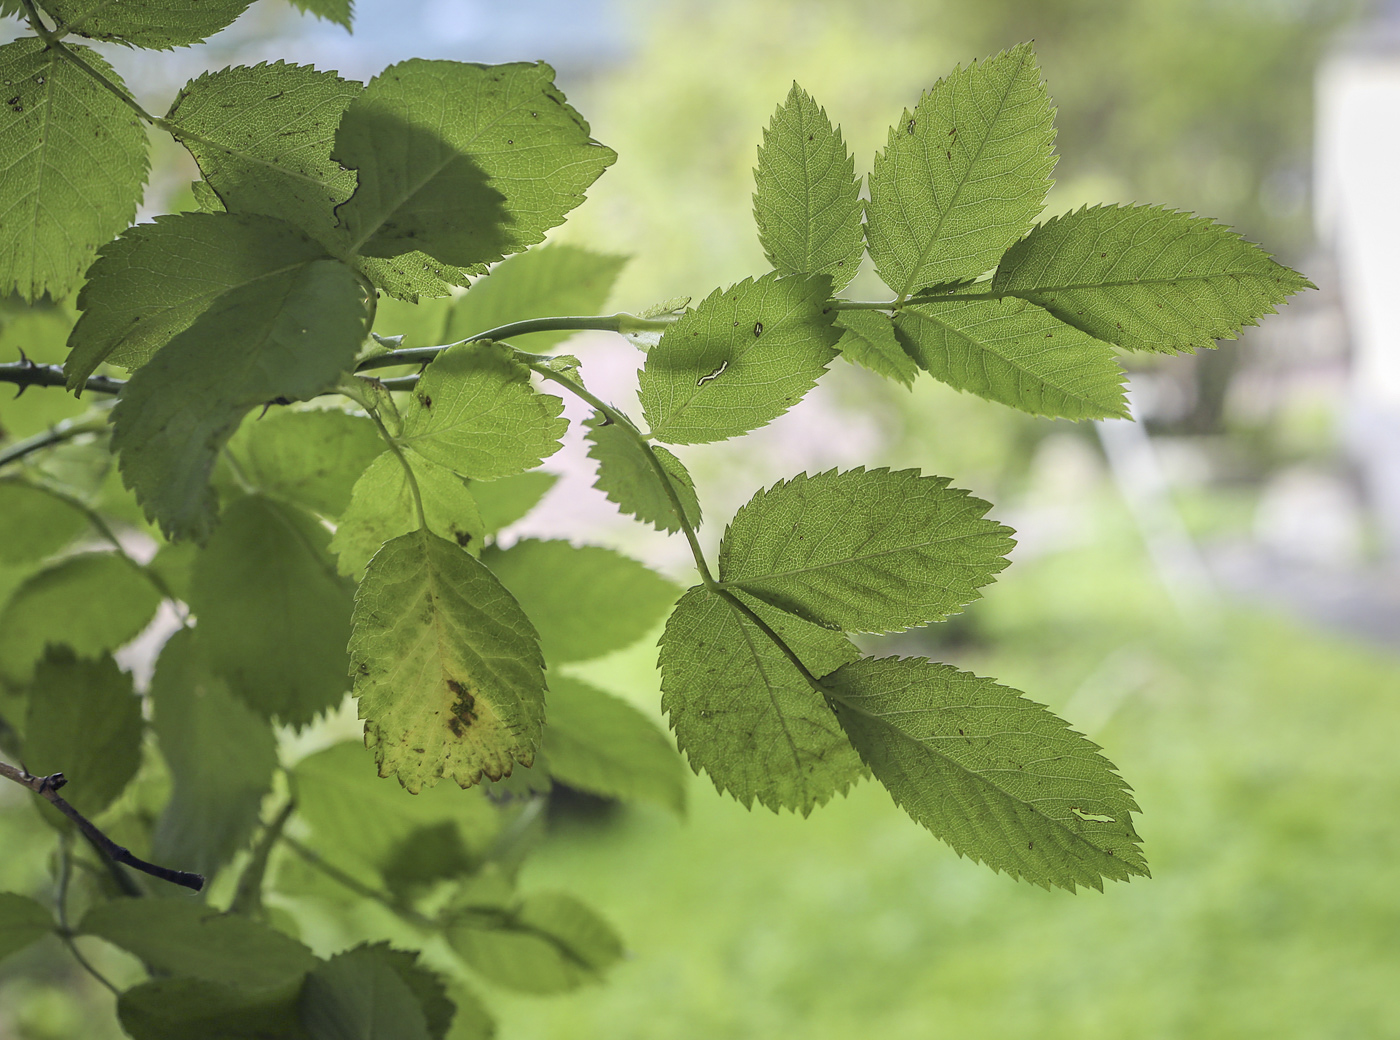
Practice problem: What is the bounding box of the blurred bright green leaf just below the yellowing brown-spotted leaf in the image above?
[291,740,500,875]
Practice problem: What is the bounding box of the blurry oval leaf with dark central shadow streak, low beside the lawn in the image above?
[447,893,623,994]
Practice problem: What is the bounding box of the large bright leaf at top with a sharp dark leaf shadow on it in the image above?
[333,59,616,267]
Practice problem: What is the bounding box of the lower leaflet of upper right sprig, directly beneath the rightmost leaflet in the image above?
[895,300,1128,419]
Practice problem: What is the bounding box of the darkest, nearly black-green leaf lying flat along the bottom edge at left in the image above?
[116,978,307,1040]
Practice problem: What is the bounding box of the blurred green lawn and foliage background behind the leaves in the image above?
[0,0,1400,1040]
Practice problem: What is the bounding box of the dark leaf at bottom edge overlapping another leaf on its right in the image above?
[301,946,431,1040]
